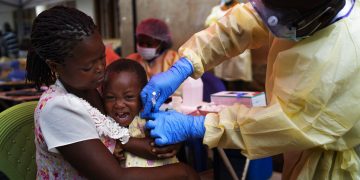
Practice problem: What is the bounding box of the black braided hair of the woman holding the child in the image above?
[26,6,96,88]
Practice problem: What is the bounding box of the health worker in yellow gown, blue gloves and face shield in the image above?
[141,0,360,179]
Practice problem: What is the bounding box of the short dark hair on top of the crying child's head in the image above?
[104,59,147,88]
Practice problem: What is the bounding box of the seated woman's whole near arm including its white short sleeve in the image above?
[40,96,196,179]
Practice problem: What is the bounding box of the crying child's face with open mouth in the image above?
[103,71,141,126]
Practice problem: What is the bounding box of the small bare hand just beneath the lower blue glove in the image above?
[151,142,182,159]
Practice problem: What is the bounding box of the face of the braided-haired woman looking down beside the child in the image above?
[57,31,105,90]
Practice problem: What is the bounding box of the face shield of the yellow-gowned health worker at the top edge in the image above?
[249,0,345,41]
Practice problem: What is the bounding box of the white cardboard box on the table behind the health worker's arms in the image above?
[211,91,266,107]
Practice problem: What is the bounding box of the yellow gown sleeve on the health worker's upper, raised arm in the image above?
[179,3,269,78]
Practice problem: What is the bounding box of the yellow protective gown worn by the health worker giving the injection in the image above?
[179,0,360,180]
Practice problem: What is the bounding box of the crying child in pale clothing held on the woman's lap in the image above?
[102,59,179,167]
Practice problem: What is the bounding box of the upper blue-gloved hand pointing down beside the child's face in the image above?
[140,57,194,118]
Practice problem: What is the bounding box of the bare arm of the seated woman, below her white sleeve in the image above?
[57,139,199,179]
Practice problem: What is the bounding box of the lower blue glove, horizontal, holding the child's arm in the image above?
[145,111,205,146]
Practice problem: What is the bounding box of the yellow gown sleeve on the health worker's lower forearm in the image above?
[204,103,324,159]
